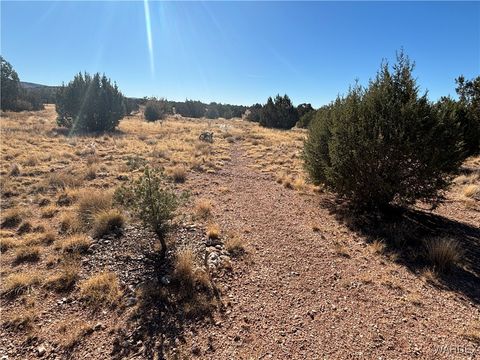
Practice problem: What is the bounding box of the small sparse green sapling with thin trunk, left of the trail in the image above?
[114,167,178,258]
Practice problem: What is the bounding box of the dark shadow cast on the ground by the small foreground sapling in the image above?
[112,240,222,359]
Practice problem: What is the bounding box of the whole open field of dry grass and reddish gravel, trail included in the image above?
[0,105,480,359]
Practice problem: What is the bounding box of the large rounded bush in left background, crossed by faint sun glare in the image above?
[56,73,125,133]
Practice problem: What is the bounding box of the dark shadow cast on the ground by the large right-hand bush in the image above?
[321,199,480,304]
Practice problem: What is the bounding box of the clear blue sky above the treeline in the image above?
[1,1,480,106]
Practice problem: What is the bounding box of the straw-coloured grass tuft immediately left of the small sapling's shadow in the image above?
[80,272,121,305]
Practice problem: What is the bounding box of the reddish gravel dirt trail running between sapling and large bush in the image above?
[191,146,479,359]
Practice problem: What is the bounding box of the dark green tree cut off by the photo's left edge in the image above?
[0,56,46,111]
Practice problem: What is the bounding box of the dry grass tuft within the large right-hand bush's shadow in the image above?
[425,238,462,272]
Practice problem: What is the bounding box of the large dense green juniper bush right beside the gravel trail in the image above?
[304,52,464,208]
